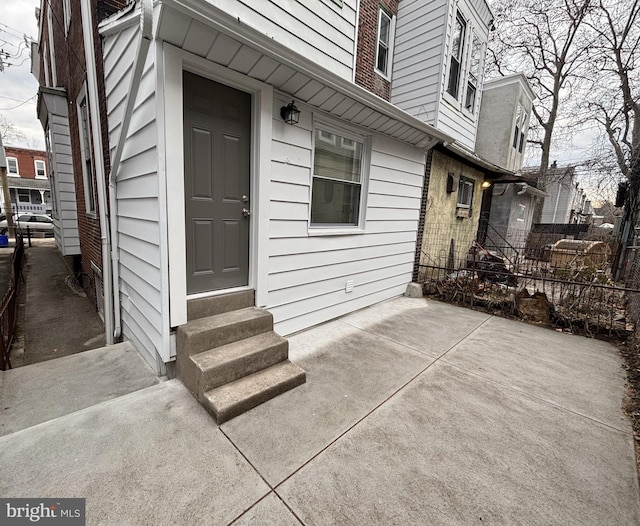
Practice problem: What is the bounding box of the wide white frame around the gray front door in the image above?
[162,42,272,327]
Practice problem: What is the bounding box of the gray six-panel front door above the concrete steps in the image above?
[183,71,251,294]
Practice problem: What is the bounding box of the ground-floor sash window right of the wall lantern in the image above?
[311,129,364,227]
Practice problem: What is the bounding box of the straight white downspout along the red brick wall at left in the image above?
[80,0,114,345]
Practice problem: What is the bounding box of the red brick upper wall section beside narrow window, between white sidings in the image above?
[355,0,399,100]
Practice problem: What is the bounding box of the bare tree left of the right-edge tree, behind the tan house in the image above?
[488,0,594,196]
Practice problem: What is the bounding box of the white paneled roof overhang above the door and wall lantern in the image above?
[100,0,454,150]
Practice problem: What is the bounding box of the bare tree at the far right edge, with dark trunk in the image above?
[587,0,640,275]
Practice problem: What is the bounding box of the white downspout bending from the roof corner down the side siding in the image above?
[107,0,153,338]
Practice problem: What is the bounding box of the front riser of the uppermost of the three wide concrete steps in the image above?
[176,315,273,356]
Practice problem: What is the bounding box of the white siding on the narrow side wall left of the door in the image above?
[104,26,164,367]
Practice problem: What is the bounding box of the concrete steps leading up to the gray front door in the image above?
[176,291,306,424]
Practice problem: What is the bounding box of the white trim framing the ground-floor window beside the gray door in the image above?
[307,119,371,237]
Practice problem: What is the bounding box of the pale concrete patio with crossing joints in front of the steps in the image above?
[0,298,640,526]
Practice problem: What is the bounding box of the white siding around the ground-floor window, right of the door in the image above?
[266,98,425,335]
